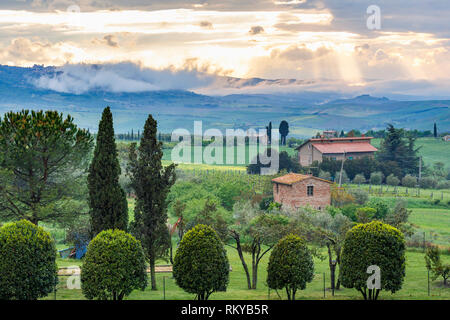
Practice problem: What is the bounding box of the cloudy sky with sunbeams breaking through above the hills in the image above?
[0,0,450,97]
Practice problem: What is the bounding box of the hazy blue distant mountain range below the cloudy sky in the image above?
[0,66,450,137]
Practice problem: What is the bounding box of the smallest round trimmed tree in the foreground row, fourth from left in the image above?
[267,234,314,300]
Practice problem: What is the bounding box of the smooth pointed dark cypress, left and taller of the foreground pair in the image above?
[88,107,128,236]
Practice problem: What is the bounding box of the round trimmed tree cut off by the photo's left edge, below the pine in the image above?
[0,220,58,300]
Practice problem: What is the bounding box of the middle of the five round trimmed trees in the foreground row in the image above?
[173,224,230,300]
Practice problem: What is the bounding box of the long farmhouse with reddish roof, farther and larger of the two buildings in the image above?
[296,136,378,167]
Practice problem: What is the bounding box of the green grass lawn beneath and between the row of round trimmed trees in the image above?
[46,248,450,300]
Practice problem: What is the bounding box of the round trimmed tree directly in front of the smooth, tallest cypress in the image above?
[81,229,147,300]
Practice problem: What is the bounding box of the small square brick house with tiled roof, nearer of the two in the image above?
[272,173,332,210]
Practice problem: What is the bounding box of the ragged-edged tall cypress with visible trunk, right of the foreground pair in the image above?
[127,115,175,290]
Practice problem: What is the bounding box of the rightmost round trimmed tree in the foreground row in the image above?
[341,221,405,300]
